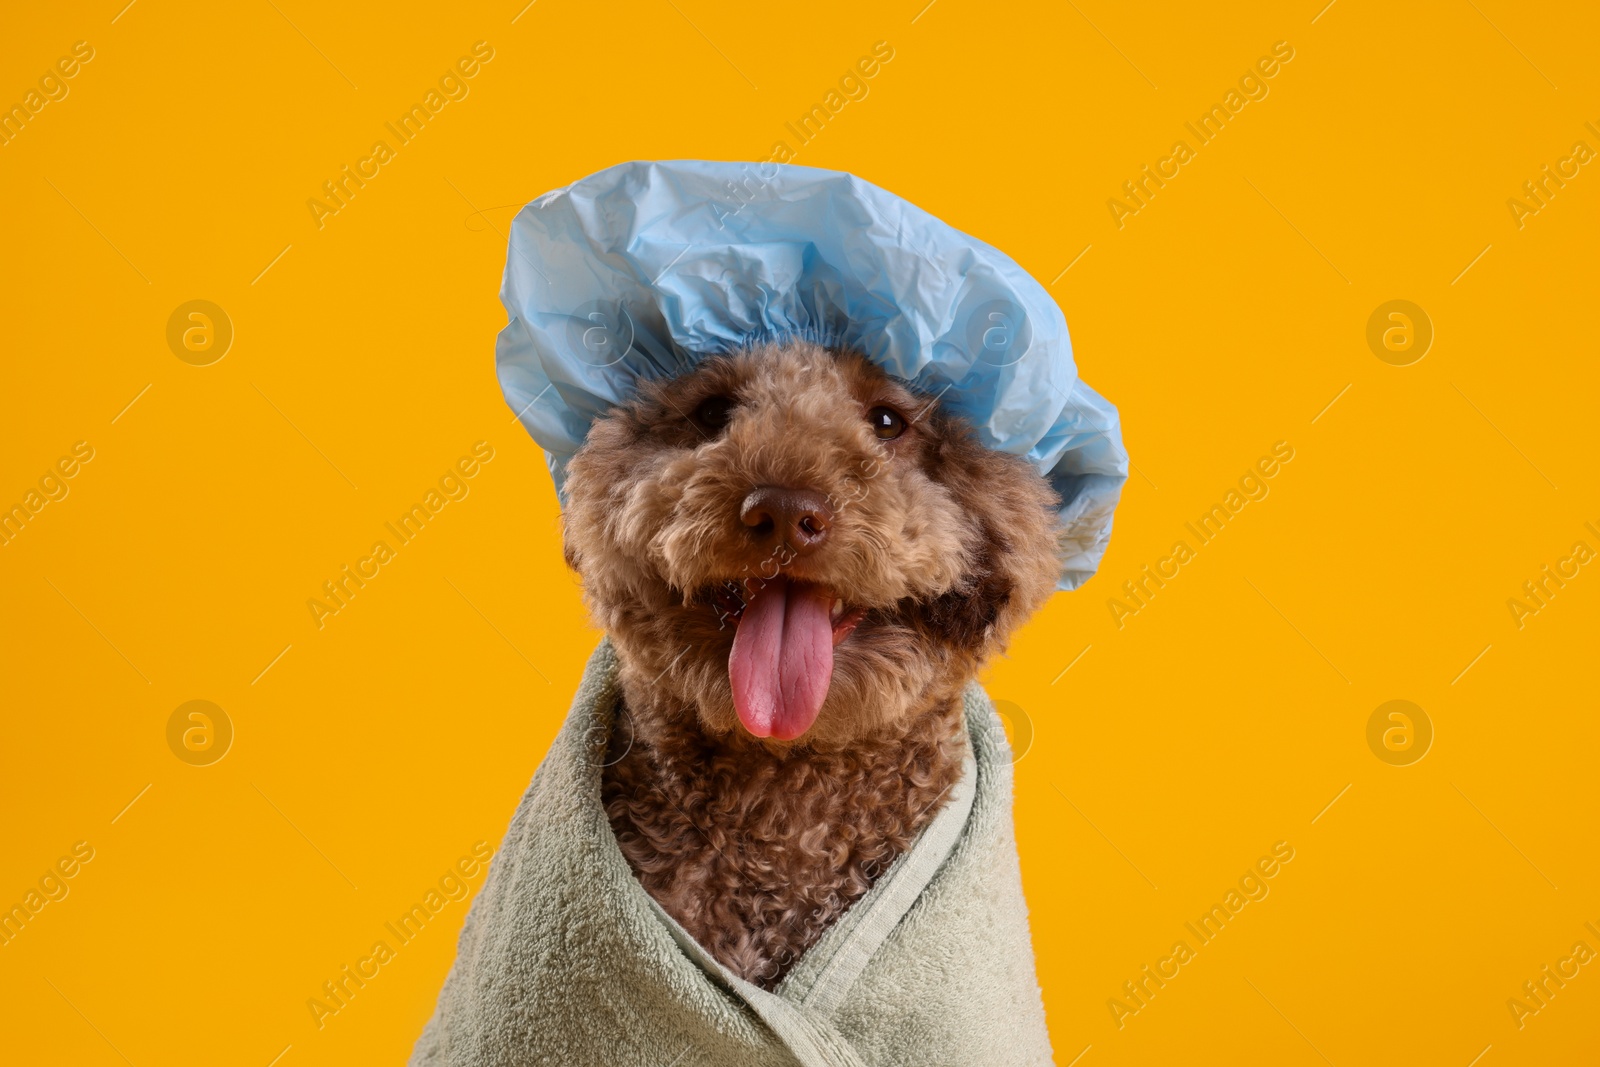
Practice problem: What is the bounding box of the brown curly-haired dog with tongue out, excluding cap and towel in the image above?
[565,342,1061,989]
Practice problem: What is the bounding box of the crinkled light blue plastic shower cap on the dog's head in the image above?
[494,160,1128,589]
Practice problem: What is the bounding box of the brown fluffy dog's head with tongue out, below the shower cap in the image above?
[565,342,1061,747]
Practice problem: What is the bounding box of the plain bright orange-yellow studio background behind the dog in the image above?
[0,0,1600,1067]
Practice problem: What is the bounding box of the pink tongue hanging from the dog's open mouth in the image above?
[728,577,834,741]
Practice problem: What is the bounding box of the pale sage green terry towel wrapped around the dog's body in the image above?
[411,641,1053,1067]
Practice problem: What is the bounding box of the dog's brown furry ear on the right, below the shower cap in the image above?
[926,414,1061,654]
